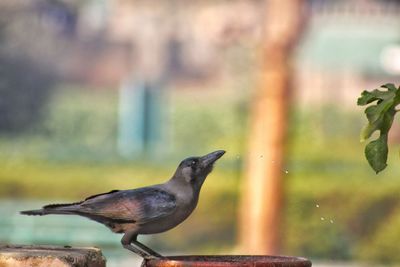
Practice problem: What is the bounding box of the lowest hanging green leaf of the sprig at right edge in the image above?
[365,134,389,173]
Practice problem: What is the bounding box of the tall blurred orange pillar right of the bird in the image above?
[239,0,305,254]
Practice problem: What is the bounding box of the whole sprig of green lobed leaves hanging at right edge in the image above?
[357,83,400,173]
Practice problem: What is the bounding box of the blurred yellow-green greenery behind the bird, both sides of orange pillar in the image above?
[0,88,400,264]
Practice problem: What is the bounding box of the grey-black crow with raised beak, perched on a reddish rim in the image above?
[20,150,225,260]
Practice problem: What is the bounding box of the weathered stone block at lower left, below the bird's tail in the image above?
[0,245,106,267]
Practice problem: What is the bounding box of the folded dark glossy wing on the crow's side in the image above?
[79,187,176,224]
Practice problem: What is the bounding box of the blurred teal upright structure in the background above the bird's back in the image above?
[118,81,168,158]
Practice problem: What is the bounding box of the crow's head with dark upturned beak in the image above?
[174,150,225,187]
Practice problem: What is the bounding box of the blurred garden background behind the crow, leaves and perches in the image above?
[0,0,400,266]
